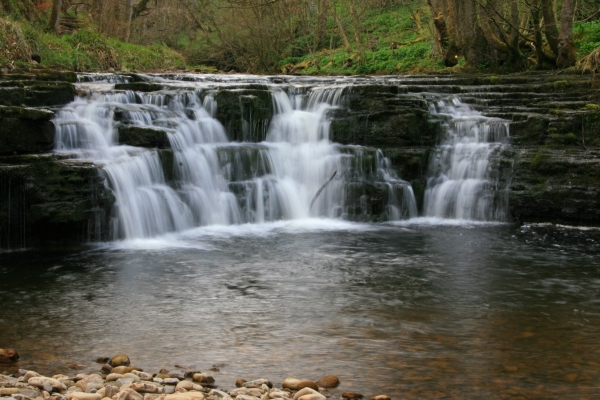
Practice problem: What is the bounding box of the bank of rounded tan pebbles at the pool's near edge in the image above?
[0,349,390,400]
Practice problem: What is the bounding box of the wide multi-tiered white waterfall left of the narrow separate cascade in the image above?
[54,79,416,239]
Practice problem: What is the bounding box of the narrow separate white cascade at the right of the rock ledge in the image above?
[424,99,509,221]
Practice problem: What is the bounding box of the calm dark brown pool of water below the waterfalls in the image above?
[0,220,600,398]
